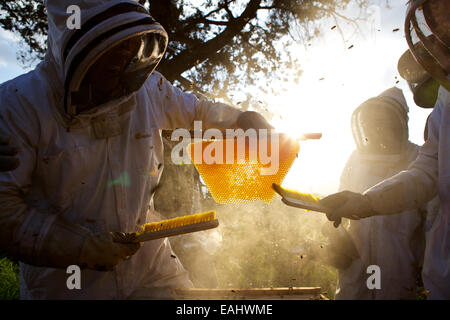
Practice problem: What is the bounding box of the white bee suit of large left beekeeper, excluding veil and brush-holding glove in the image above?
[0,0,244,299]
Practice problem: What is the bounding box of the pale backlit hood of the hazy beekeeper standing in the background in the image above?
[352,87,409,155]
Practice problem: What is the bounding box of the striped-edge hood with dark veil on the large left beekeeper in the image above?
[46,0,168,116]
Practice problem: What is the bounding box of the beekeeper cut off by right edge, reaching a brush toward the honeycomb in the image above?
[322,0,450,299]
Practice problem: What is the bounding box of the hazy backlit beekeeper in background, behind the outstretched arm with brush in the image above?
[334,88,425,300]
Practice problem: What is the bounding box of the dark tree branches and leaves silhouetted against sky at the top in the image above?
[0,0,367,102]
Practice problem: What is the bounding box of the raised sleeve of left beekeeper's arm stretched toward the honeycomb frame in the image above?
[147,72,242,130]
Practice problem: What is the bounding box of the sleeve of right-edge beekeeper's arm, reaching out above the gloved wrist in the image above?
[365,103,443,215]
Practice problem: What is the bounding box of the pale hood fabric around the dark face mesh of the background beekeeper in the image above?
[352,87,409,160]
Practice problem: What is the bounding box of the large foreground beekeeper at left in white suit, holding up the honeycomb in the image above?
[0,0,268,299]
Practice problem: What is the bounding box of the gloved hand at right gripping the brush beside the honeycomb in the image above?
[320,191,377,228]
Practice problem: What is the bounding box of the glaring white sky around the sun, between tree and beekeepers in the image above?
[0,0,430,198]
